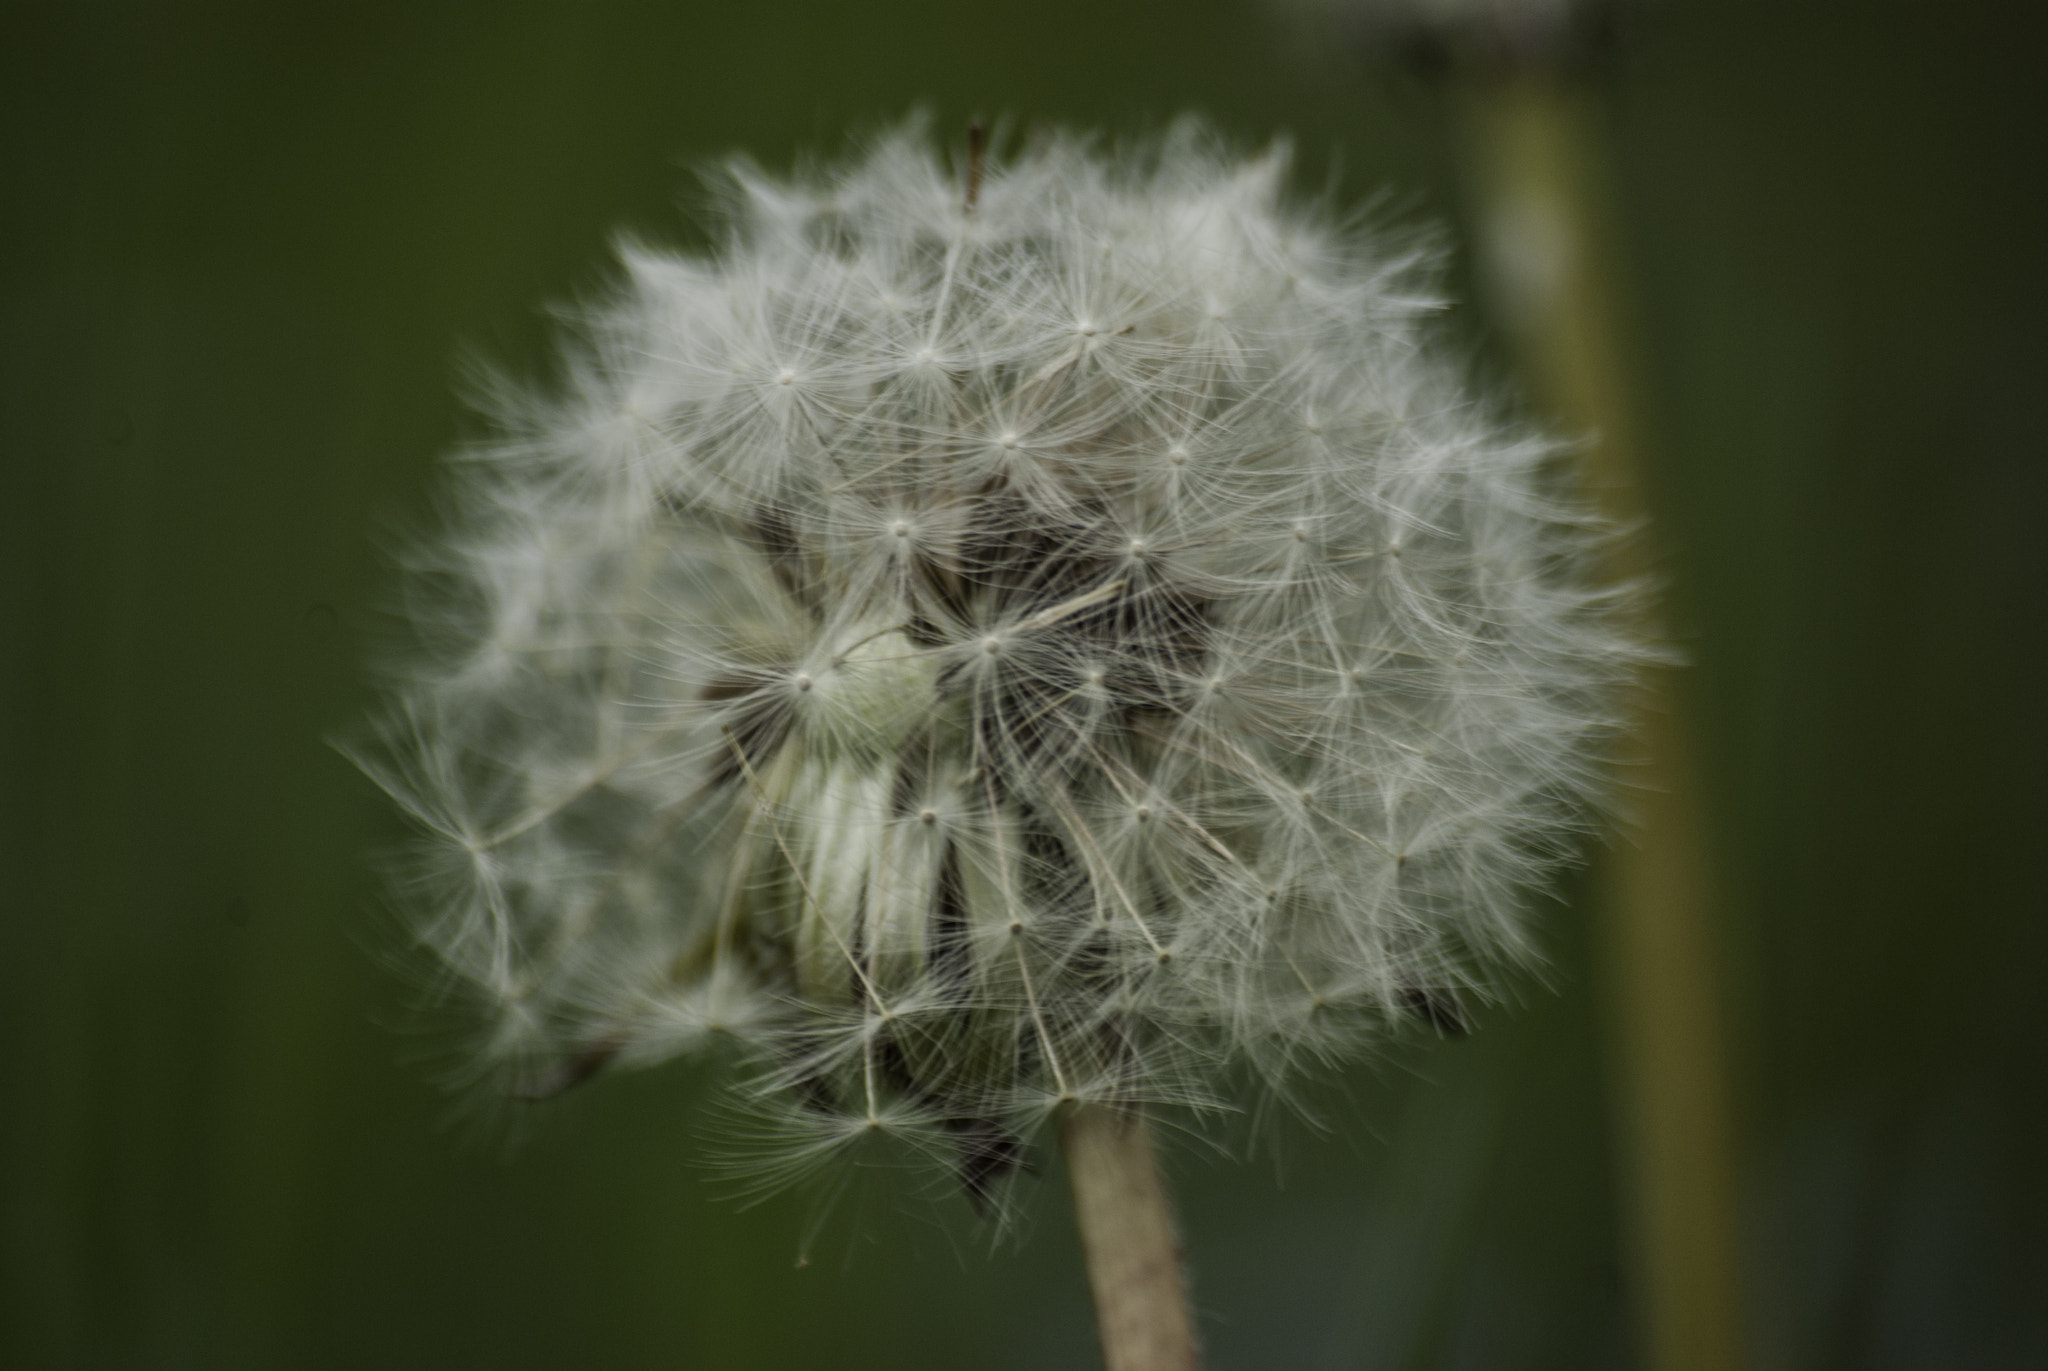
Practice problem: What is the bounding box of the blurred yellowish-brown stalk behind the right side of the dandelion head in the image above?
[1466,76,1743,1371]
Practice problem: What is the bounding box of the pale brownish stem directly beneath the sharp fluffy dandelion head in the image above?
[1059,1105,1200,1371]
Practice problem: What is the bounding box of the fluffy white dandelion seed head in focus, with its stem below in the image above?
[362,125,1638,1365]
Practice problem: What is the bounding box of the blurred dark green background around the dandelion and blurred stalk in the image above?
[0,0,2048,1371]
